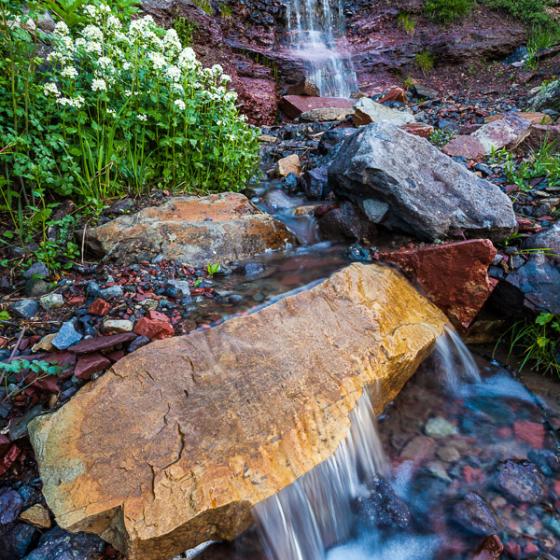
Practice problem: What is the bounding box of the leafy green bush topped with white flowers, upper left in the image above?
[0,0,258,238]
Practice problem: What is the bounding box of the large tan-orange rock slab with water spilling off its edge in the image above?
[30,264,446,560]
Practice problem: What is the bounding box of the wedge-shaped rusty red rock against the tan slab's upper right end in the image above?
[379,239,496,329]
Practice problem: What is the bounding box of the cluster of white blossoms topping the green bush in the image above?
[44,4,241,122]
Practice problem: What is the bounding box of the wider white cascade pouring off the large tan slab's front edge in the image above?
[255,394,389,560]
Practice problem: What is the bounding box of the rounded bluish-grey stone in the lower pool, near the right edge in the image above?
[496,460,545,504]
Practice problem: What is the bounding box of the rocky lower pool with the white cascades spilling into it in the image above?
[195,330,560,560]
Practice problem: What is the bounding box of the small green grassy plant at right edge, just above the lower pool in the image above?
[500,313,560,375]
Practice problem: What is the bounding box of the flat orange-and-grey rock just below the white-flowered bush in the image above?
[87,193,295,266]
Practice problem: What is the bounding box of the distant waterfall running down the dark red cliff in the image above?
[286,0,358,97]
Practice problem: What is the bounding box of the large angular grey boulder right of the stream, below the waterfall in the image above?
[329,123,517,241]
